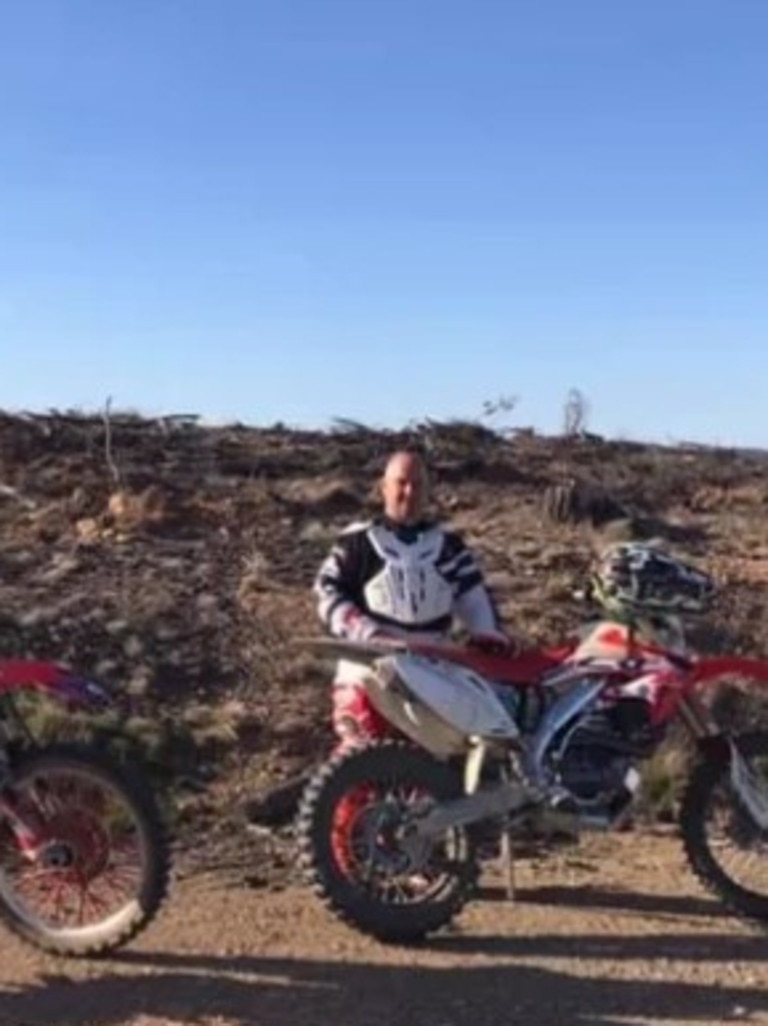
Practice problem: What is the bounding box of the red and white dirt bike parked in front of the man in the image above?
[296,599,768,942]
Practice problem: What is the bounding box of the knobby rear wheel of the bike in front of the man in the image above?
[296,742,478,942]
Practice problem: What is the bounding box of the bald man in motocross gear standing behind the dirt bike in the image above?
[314,451,513,746]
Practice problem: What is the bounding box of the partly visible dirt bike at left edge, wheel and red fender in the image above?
[0,660,170,956]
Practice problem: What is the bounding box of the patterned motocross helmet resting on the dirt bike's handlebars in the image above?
[590,542,715,618]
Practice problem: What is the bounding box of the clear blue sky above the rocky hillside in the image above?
[0,0,768,445]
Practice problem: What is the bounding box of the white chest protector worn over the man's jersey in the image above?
[364,525,453,626]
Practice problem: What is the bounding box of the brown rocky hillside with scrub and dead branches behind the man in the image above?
[0,409,768,829]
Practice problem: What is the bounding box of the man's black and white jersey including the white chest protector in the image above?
[314,517,499,641]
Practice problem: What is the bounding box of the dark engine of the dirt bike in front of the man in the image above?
[556,697,660,810]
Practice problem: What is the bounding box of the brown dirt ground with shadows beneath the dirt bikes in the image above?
[0,828,768,1026]
